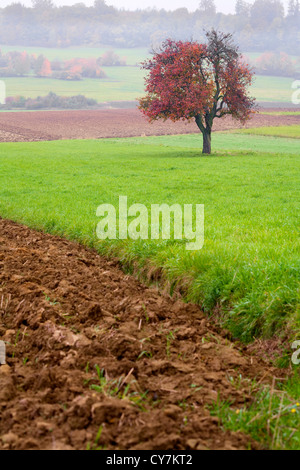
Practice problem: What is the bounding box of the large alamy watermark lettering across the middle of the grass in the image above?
[96,196,204,250]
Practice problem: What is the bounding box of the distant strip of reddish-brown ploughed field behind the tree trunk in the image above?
[0,109,300,142]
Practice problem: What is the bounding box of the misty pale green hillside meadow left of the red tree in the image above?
[0,46,149,102]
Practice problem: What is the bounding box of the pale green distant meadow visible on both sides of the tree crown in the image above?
[0,46,294,102]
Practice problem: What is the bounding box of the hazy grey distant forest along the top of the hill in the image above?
[0,0,300,54]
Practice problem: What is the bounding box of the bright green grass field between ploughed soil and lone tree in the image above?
[0,133,300,341]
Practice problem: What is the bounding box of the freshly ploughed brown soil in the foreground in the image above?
[0,219,282,450]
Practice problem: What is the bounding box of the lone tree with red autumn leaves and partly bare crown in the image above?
[139,29,255,154]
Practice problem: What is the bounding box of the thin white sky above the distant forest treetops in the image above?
[0,0,288,13]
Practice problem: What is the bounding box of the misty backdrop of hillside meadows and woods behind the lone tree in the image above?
[0,0,300,109]
